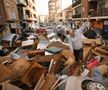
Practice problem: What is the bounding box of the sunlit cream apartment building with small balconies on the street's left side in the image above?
[23,0,37,28]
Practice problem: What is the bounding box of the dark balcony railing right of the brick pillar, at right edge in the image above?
[89,7,108,17]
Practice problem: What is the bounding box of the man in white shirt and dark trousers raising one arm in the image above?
[68,17,90,61]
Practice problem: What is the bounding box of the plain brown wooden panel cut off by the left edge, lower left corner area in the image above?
[0,64,12,83]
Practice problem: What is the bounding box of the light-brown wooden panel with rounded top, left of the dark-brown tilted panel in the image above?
[9,58,30,79]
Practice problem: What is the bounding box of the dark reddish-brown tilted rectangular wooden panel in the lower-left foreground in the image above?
[21,62,47,87]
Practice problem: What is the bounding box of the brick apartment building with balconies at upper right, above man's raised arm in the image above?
[72,0,108,29]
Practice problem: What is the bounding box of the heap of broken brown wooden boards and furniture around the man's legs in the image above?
[0,34,108,90]
